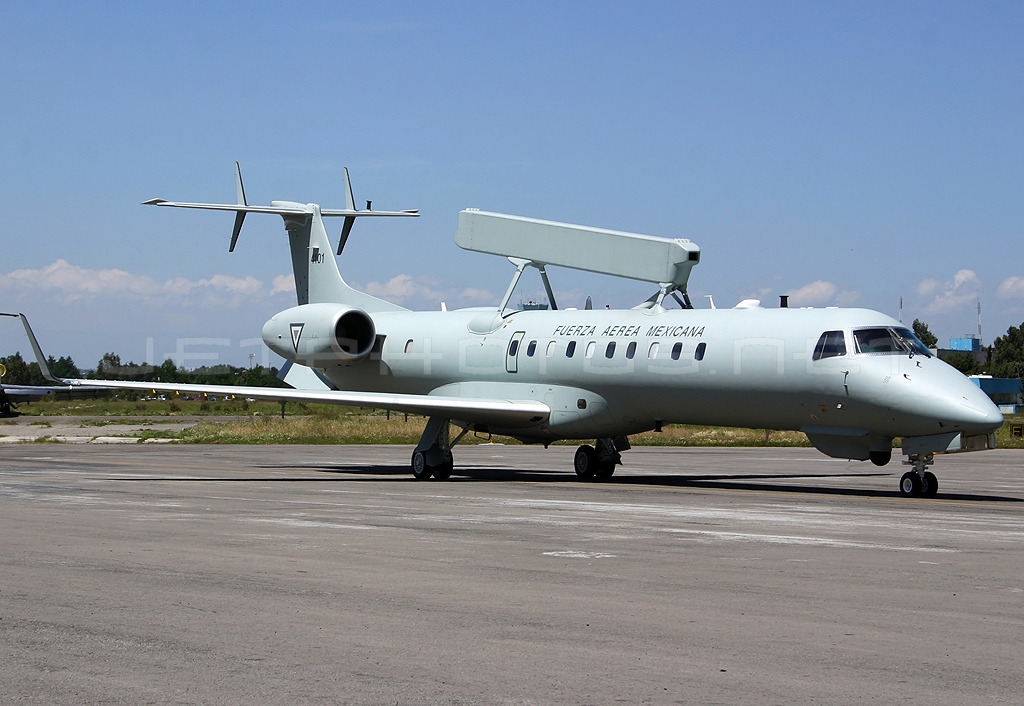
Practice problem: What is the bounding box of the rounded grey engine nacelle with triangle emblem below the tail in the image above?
[263,304,377,368]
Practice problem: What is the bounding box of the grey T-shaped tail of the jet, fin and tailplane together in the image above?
[142,162,420,313]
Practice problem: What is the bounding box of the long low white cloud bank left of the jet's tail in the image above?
[0,259,294,306]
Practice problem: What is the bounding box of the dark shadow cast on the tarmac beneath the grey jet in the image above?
[247,464,1024,503]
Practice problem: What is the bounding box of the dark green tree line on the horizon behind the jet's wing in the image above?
[0,352,288,387]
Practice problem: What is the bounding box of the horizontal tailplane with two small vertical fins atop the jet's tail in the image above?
[142,162,420,255]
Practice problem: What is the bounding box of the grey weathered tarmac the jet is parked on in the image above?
[0,445,1024,704]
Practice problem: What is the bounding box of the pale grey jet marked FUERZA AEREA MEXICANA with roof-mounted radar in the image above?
[6,163,1004,497]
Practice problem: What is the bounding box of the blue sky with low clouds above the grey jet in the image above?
[0,2,1024,367]
